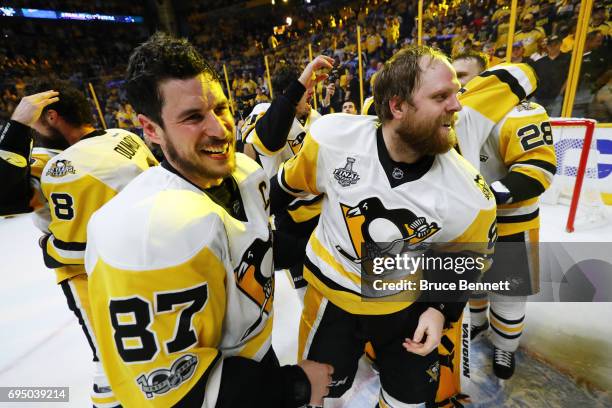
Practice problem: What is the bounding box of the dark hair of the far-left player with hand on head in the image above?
[28,78,93,127]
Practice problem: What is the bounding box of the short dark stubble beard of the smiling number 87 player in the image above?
[164,131,236,180]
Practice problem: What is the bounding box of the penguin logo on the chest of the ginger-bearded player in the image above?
[336,197,440,264]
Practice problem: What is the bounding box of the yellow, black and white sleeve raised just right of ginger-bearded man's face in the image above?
[456,64,537,169]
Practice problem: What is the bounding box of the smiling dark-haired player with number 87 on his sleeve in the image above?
[86,34,333,407]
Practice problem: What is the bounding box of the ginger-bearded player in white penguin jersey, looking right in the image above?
[271,47,495,407]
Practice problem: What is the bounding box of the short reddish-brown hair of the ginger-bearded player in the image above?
[373,45,448,123]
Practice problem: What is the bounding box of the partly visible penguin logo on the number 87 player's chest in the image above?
[234,235,274,341]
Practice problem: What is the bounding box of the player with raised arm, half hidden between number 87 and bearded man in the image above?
[241,55,334,289]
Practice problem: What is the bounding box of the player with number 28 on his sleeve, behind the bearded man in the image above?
[453,54,556,379]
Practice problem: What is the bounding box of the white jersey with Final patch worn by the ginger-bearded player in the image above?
[278,114,495,314]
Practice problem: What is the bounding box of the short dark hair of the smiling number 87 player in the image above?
[124,32,221,127]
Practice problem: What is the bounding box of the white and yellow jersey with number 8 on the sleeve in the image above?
[40,129,158,283]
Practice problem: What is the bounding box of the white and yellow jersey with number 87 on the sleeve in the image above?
[86,154,274,407]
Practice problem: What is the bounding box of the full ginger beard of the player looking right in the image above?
[396,115,456,156]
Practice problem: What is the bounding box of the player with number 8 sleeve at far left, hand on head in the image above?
[0,81,157,408]
